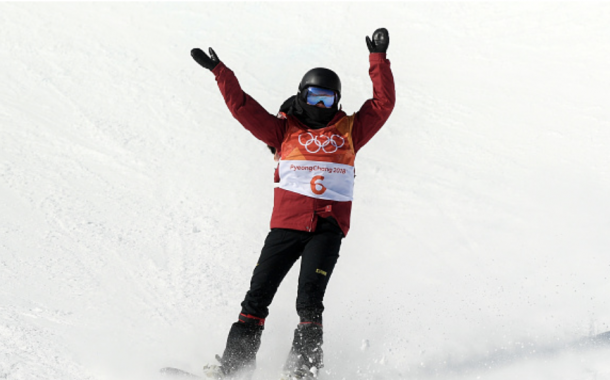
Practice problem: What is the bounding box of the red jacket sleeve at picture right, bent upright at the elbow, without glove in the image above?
[352,53,396,152]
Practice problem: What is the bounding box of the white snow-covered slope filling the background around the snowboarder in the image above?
[0,2,610,380]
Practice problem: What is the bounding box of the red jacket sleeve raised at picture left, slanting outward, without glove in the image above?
[212,62,286,149]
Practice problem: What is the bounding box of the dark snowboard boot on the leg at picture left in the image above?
[216,314,264,379]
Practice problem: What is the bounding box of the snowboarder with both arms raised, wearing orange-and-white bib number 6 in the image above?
[191,28,395,378]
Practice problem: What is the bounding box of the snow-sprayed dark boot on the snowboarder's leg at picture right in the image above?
[284,323,324,380]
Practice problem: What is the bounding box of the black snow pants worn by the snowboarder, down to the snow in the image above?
[221,218,343,373]
